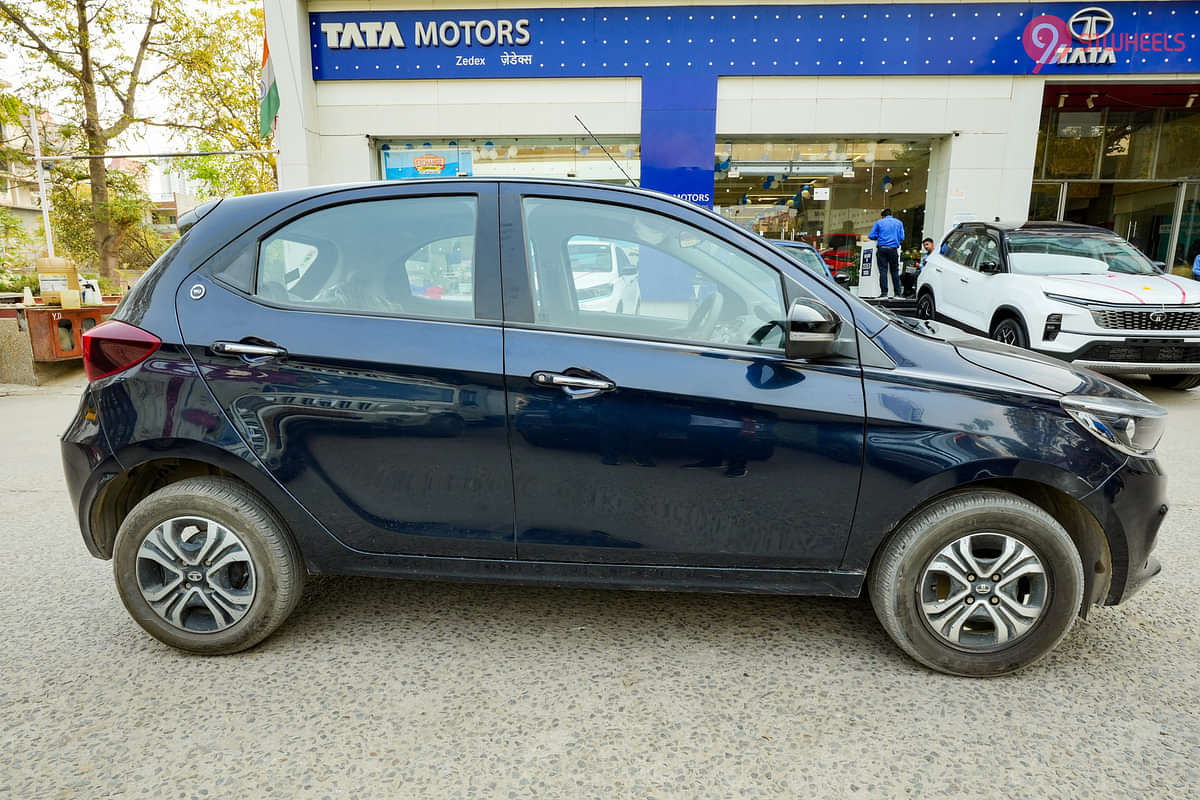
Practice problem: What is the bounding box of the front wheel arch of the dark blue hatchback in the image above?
[869,476,1112,618]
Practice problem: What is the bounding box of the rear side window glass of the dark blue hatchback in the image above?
[254,197,478,319]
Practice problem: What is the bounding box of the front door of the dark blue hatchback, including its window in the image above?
[502,185,864,569]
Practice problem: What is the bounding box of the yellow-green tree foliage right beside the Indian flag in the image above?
[164,6,277,198]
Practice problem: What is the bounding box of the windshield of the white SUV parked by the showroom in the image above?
[1008,231,1159,275]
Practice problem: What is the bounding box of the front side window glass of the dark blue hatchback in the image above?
[523,198,786,349]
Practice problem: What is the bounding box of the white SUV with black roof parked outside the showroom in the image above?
[917,222,1200,389]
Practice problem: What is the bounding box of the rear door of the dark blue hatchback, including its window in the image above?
[176,184,515,558]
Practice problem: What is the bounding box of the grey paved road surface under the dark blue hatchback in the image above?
[0,371,1200,799]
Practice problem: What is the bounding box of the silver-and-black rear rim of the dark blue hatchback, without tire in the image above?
[137,517,256,633]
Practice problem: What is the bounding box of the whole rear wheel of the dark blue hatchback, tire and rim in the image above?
[113,477,305,655]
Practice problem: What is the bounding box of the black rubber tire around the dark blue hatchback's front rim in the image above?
[868,489,1084,678]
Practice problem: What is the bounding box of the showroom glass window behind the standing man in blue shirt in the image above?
[713,137,930,270]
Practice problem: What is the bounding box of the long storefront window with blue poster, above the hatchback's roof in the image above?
[379,137,642,184]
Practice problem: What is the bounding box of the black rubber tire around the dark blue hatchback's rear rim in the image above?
[113,476,305,655]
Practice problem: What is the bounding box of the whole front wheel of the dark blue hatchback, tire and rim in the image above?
[869,489,1084,678]
